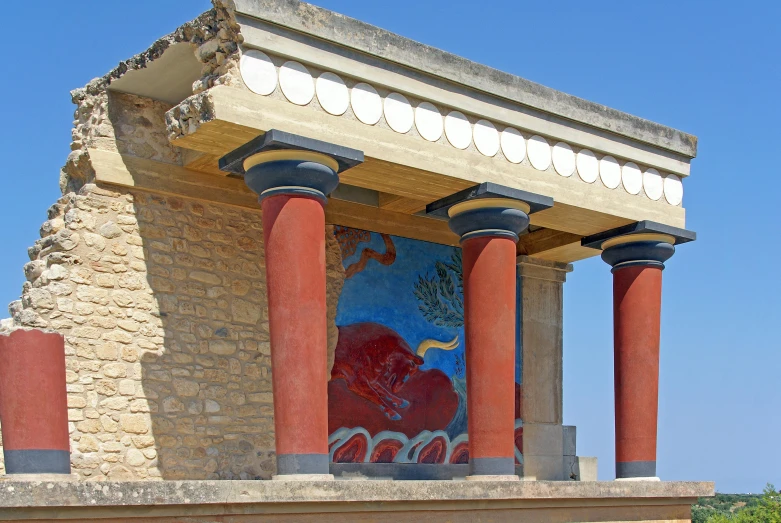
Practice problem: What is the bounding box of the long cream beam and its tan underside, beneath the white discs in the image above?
[172,86,685,236]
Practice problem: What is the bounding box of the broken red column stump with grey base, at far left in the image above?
[0,329,71,474]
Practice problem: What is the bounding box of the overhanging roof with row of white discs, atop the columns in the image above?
[96,0,696,262]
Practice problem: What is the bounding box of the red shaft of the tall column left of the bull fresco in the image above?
[261,195,328,462]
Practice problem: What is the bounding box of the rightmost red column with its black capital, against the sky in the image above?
[581,221,697,480]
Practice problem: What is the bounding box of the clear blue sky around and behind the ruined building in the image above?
[0,0,781,492]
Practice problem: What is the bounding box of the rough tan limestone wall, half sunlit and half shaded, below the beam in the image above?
[4,184,344,480]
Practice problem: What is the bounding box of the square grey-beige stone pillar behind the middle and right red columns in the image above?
[517,256,572,480]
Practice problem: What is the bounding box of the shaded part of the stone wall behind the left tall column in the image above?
[133,190,343,479]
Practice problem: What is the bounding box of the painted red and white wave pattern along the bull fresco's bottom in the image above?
[328,419,523,464]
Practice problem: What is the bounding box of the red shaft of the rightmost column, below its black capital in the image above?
[613,266,662,477]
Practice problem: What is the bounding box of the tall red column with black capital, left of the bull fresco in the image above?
[220,129,363,479]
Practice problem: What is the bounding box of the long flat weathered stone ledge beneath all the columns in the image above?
[0,479,714,510]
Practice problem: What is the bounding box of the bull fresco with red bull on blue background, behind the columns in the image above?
[328,227,523,464]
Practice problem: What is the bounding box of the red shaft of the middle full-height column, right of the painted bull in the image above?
[462,237,516,466]
